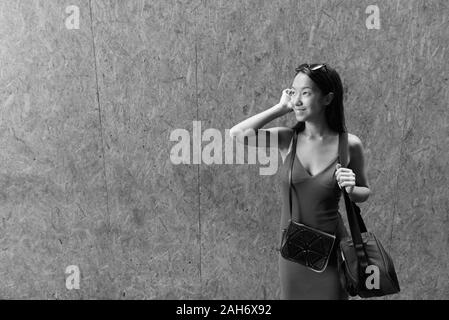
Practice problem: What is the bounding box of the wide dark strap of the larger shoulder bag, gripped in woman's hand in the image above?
[338,132,368,270]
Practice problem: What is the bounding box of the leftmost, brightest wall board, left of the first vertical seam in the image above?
[0,1,110,299]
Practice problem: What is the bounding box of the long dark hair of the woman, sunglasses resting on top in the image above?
[292,63,347,133]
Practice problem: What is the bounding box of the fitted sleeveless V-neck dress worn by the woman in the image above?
[278,128,348,300]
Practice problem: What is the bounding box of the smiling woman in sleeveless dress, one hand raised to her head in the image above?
[230,64,371,299]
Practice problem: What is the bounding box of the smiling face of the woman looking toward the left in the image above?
[291,72,325,121]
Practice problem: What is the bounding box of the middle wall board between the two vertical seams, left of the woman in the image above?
[93,1,200,299]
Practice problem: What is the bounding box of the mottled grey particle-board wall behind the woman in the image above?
[0,0,449,299]
